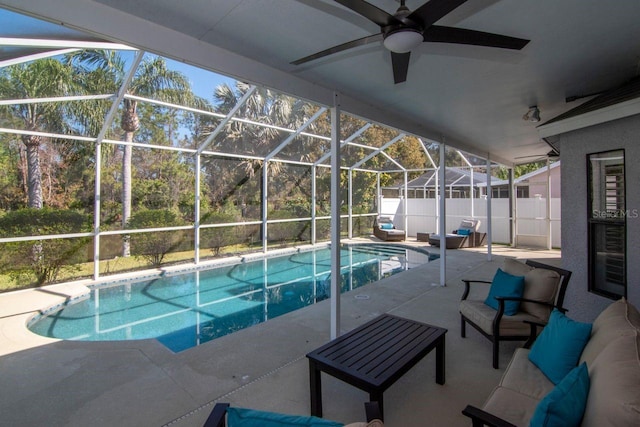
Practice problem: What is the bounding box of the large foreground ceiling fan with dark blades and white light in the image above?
[291,0,529,84]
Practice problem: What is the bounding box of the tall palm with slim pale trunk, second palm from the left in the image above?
[68,50,205,256]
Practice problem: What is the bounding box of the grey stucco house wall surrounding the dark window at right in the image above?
[559,115,640,321]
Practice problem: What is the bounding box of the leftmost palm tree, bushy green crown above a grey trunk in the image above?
[0,58,77,209]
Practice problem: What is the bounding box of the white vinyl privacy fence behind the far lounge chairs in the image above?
[380,197,561,248]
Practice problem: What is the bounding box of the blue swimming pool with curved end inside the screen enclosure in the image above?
[29,244,437,352]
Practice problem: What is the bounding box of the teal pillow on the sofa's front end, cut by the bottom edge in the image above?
[529,363,591,427]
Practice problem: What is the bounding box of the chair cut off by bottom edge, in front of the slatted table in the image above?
[204,402,384,427]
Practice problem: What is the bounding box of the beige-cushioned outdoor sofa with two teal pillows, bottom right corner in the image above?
[462,298,640,427]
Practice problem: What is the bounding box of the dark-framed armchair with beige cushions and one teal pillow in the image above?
[460,258,571,369]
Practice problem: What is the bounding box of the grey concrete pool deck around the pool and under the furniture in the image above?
[0,241,560,427]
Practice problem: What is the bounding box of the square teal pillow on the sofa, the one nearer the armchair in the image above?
[529,309,591,384]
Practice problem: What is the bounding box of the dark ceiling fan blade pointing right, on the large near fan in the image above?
[424,25,529,50]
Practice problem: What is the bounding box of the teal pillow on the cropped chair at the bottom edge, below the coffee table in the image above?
[227,406,344,427]
